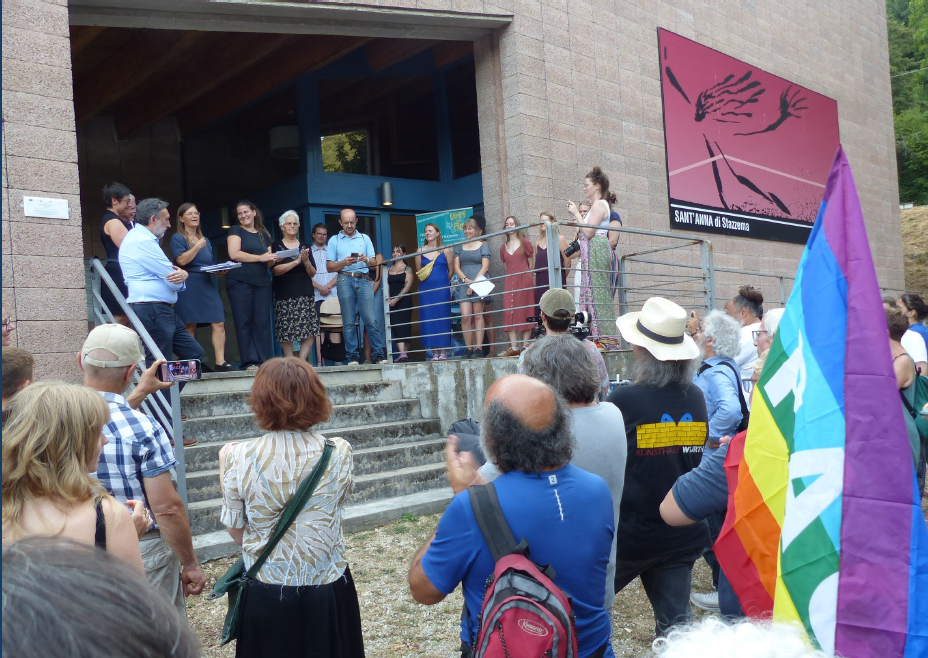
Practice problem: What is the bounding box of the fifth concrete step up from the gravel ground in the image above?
[184,399,421,441]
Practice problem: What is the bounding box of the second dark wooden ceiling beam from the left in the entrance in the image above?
[116,33,299,137]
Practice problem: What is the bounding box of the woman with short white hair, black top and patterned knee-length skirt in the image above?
[272,210,319,361]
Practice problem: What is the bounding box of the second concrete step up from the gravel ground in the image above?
[187,462,447,535]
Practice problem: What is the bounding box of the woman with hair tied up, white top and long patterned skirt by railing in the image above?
[567,167,615,337]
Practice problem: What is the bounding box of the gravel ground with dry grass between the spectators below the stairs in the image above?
[187,515,711,658]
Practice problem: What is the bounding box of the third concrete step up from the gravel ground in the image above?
[187,437,444,502]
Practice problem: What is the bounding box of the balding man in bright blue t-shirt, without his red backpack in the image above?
[409,375,614,658]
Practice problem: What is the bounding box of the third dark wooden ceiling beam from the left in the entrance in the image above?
[177,35,369,136]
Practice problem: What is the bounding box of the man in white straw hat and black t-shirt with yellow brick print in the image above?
[609,297,709,635]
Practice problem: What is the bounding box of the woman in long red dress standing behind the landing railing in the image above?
[499,216,535,356]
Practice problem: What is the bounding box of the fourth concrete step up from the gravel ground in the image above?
[184,418,441,468]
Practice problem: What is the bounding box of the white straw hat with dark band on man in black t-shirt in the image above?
[615,297,699,361]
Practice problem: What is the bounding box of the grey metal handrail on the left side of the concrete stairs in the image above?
[90,258,187,507]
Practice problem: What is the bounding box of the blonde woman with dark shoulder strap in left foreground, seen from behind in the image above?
[3,382,143,572]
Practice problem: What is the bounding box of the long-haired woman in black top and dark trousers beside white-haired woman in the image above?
[226,201,277,370]
